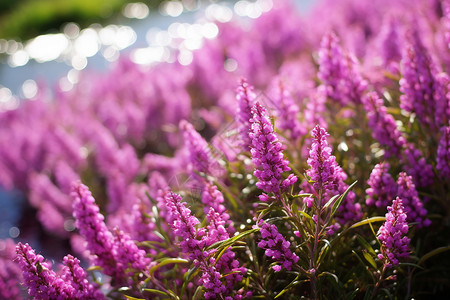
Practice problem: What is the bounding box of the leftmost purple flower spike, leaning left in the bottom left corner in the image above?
[16,243,73,300]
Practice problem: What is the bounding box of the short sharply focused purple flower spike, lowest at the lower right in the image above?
[377,197,410,268]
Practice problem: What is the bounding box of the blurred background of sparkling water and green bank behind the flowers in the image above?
[0,0,314,239]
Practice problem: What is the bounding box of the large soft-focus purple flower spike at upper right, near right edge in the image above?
[400,30,442,128]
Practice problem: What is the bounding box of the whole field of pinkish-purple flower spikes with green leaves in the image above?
[0,0,450,300]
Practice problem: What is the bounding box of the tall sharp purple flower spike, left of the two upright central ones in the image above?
[249,103,297,200]
